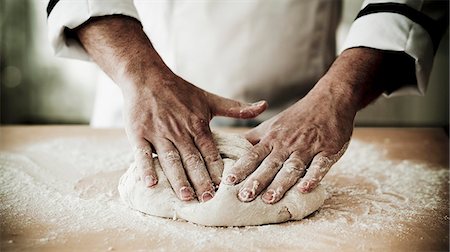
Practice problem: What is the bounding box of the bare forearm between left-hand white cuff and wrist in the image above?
[75,15,168,87]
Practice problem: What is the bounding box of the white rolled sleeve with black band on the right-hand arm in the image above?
[342,0,448,95]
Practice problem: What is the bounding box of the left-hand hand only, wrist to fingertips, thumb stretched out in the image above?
[122,67,267,202]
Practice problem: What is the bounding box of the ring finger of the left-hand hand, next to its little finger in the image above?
[154,139,195,201]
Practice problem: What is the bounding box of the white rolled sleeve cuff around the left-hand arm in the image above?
[47,0,139,60]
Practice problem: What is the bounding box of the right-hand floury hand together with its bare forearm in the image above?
[223,48,394,204]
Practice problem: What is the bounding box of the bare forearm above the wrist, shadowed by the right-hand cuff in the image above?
[318,48,415,112]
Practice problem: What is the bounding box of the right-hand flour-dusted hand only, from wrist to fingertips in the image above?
[224,79,356,203]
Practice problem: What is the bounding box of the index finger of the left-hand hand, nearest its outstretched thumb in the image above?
[194,127,223,186]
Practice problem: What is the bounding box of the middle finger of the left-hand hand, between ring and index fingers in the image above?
[176,139,215,202]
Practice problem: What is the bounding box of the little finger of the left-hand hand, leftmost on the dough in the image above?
[134,139,158,187]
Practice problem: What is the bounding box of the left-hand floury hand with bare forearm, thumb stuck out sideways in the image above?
[75,16,267,201]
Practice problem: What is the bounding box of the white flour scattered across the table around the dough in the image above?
[0,135,449,250]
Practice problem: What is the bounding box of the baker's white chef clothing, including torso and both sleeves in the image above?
[47,0,446,126]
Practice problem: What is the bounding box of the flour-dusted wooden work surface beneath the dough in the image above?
[0,126,449,251]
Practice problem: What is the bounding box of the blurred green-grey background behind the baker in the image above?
[0,0,449,126]
